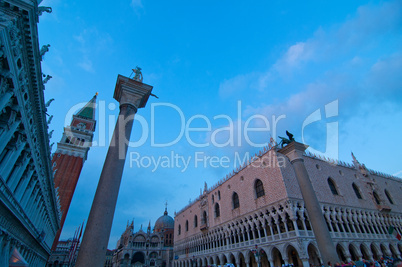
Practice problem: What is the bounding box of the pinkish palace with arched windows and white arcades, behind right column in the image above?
[173,148,402,267]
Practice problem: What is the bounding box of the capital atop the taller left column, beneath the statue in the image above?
[113,74,153,109]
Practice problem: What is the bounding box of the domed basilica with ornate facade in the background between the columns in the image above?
[113,210,174,267]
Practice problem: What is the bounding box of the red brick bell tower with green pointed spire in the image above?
[52,93,98,250]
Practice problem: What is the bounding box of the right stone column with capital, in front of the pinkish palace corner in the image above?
[279,141,339,266]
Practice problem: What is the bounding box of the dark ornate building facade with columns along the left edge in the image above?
[0,0,61,266]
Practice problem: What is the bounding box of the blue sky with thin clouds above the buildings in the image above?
[39,0,402,248]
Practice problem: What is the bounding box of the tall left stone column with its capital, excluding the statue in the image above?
[76,75,152,267]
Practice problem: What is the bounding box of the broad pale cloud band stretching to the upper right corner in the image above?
[219,1,402,102]
